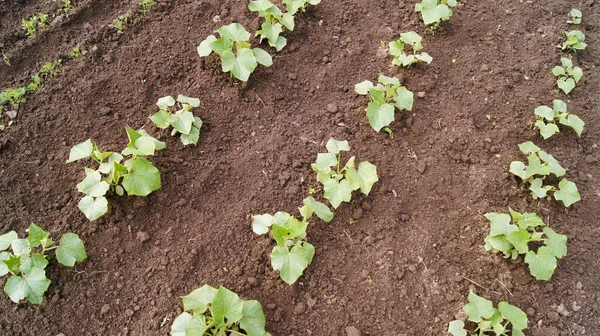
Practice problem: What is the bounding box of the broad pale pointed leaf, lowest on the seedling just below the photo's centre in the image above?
[271,242,315,285]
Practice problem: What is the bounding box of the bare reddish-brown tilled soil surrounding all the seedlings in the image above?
[0,0,600,336]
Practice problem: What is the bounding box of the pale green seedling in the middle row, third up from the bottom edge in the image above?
[312,139,379,209]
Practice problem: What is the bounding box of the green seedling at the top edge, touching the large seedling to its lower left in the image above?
[248,0,294,51]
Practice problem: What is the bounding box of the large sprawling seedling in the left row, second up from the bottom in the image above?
[67,127,165,221]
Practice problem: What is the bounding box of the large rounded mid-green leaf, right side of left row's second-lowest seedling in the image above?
[123,158,161,196]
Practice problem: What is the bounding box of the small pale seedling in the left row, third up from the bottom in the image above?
[150,95,202,146]
